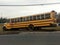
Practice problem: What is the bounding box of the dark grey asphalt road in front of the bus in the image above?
[0,31,60,45]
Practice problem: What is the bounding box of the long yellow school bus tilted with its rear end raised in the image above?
[3,11,57,30]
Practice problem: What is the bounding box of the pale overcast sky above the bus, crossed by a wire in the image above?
[0,0,60,18]
